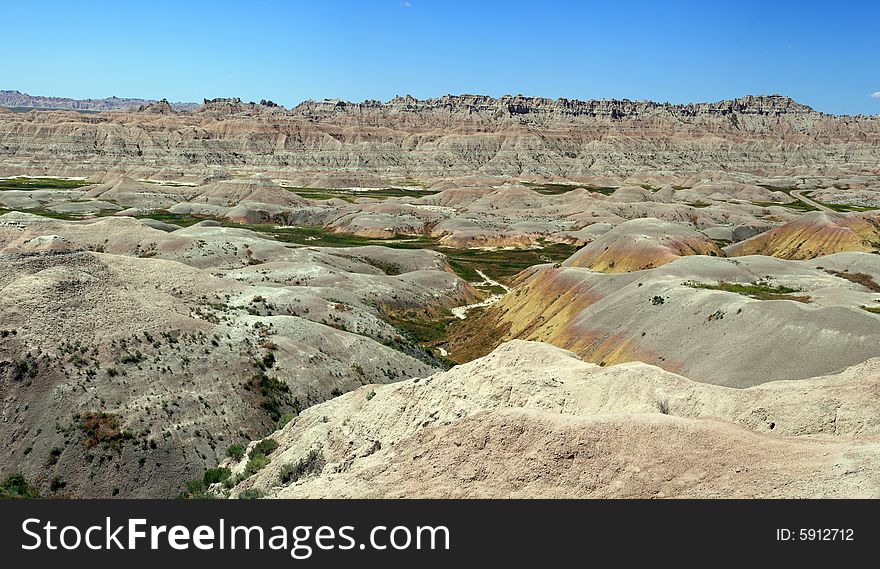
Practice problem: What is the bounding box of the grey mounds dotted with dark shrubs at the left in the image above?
[0,213,476,497]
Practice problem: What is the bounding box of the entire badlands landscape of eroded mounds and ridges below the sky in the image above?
[0,91,880,497]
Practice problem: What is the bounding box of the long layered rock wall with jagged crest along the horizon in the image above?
[0,95,880,179]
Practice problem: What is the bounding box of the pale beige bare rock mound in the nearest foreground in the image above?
[233,341,880,498]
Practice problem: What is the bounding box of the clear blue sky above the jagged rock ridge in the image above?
[0,0,880,114]
